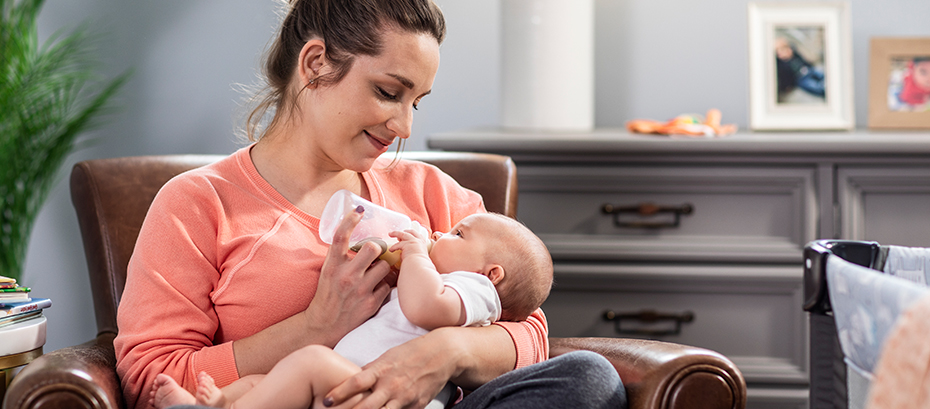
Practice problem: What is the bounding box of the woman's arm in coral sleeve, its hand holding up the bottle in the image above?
[114,180,389,407]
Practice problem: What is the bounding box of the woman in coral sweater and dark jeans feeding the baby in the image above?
[114,0,624,409]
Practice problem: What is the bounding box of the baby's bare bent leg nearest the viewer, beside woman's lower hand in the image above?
[232,345,361,409]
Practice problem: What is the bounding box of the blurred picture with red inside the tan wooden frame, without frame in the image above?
[888,55,930,112]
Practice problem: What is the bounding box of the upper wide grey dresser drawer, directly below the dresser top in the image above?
[518,165,818,263]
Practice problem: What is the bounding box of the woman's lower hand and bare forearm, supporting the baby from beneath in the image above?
[324,325,516,409]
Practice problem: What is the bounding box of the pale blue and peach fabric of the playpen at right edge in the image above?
[827,246,930,409]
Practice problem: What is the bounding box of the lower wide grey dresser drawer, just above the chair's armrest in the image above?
[543,263,809,384]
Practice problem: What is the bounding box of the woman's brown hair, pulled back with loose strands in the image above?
[245,0,446,141]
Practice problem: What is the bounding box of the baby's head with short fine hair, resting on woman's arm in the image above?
[430,213,552,321]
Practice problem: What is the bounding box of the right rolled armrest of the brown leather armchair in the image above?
[549,338,746,409]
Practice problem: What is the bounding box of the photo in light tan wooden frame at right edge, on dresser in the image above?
[869,37,930,129]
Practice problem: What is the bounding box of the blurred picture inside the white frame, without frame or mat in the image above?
[774,26,826,104]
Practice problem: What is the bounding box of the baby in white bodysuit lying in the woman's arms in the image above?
[150,213,552,409]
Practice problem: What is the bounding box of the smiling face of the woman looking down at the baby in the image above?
[298,29,439,172]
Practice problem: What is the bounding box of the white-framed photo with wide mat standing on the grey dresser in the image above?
[749,2,856,130]
